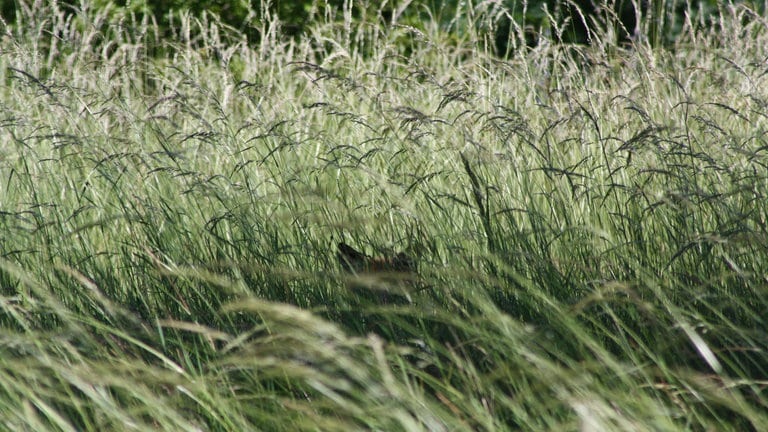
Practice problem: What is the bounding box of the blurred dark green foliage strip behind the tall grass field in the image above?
[0,0,765,56]
